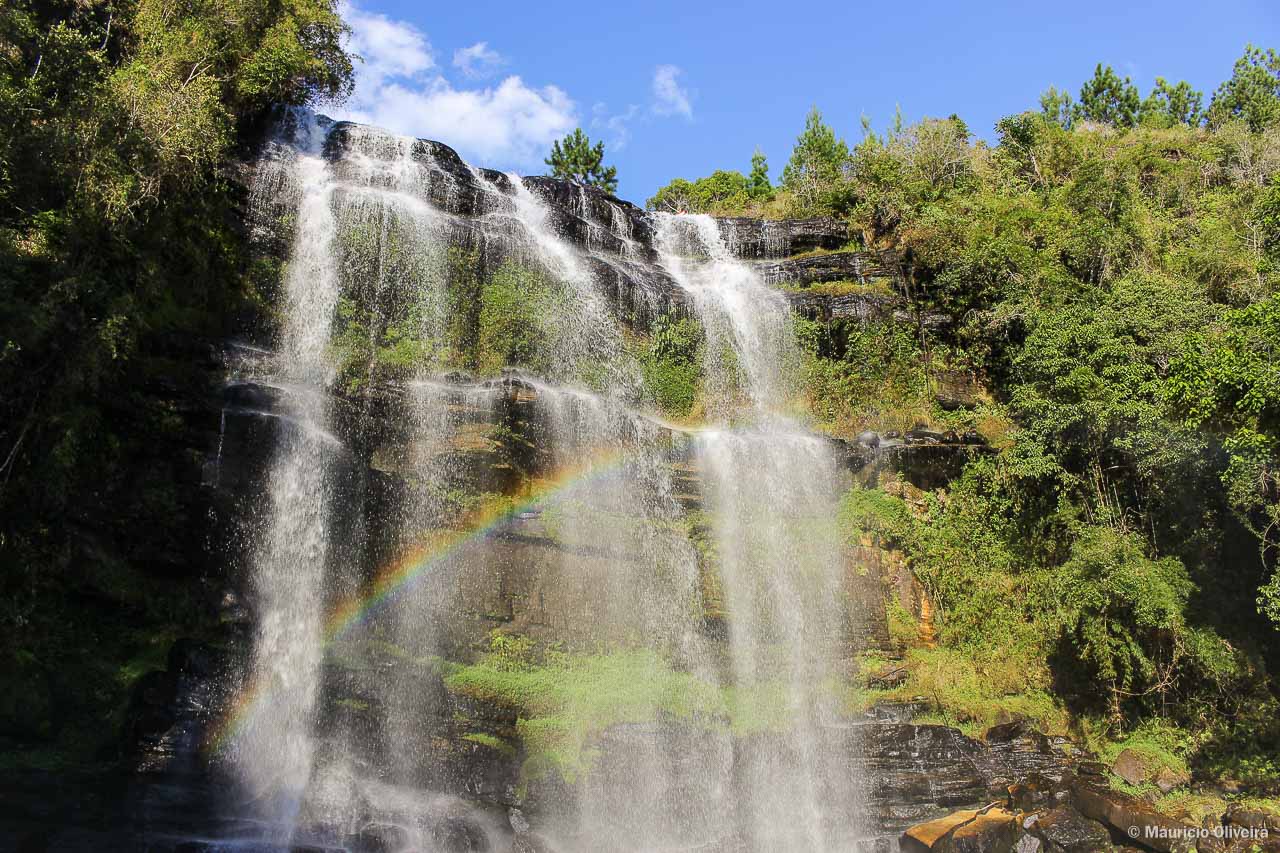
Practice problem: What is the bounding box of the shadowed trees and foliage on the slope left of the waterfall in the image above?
[0,0,352,760]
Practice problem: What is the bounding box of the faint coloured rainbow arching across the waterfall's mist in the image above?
[205,450,626,753]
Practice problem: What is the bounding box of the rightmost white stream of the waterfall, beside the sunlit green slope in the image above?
[658,214,856,850]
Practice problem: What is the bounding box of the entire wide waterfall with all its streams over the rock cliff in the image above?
[215,113,858,852]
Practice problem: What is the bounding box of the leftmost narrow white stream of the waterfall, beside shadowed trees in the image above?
[236,111,339,840]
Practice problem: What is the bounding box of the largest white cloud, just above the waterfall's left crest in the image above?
[330,4,577,168]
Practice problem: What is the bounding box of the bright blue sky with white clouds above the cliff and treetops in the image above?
[328,0,1280,204]
